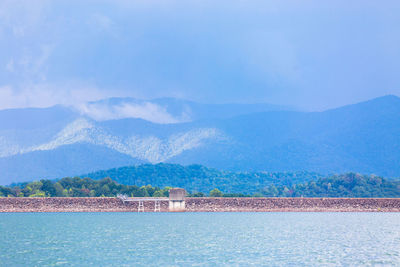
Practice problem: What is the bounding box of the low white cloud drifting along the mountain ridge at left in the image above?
[0,83,190,124]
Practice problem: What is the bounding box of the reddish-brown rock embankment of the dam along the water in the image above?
[0,198,400,212]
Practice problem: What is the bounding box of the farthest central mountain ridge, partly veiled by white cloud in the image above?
[78,97,294,124]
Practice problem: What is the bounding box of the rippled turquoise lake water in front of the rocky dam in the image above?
[0,213,400,266]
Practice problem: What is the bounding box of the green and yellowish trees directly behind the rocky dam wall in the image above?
[0,173,400,197]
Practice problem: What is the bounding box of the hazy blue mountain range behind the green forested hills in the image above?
[0,96,400,184]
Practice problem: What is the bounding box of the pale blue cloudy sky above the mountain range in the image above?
[0,0,400,111]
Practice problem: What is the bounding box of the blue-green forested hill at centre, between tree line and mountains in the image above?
[80,163,322,193]
